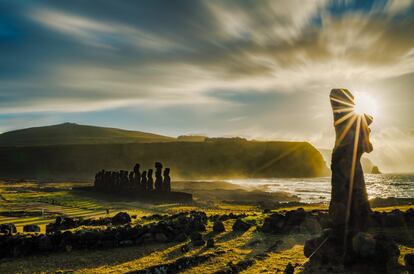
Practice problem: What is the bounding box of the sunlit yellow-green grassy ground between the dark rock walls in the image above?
[0,182,414,274]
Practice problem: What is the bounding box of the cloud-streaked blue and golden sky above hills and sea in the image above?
[0,0,414,172]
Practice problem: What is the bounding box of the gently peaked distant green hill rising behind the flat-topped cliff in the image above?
[0,123,175,146]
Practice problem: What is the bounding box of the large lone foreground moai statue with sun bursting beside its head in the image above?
[329,89,373,240]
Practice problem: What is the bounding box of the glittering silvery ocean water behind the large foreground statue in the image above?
[226,174,414,203]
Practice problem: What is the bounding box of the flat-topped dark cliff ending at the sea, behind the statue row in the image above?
[0,138,328,180]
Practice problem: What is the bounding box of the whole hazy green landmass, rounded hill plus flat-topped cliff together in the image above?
[0,123,328,180]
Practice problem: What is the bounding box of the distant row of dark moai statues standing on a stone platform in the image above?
[94,162,171,192]
